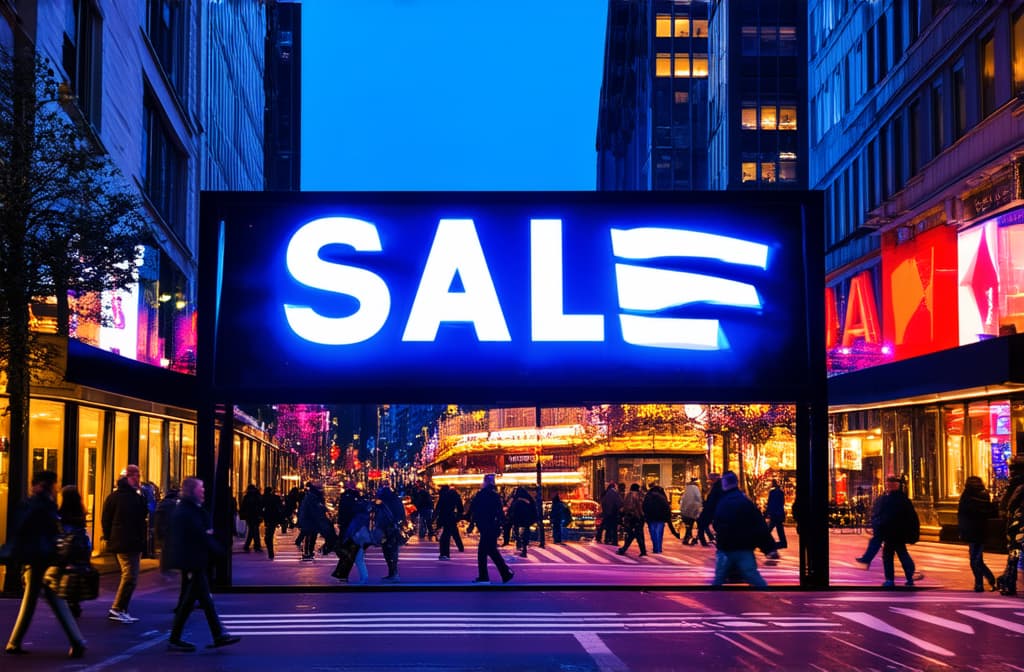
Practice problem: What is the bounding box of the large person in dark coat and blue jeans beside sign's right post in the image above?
[705,471,778,588]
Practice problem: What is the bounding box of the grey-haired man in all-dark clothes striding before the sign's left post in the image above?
[168,476,241,652]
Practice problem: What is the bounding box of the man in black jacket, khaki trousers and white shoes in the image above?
[102,464,148,623]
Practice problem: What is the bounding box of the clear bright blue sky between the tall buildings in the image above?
[302,0,607,191]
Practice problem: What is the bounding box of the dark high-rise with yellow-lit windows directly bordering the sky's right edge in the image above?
[597,0,708,191]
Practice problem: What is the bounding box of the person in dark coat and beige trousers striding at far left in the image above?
[4,471,85,658]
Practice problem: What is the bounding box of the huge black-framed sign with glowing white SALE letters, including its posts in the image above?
[197,192,828,588]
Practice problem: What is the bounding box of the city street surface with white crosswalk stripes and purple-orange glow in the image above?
[0,534,1024,672]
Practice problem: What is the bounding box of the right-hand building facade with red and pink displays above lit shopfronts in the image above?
[809,0,1024,539]
